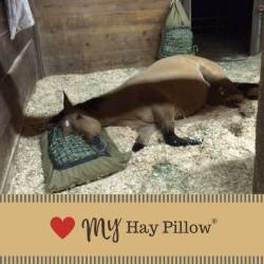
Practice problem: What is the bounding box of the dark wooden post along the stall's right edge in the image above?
[253,5,264,194]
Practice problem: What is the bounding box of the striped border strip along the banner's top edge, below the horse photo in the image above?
[0,194,264,204]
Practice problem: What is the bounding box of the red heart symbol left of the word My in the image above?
[50,216,75,239]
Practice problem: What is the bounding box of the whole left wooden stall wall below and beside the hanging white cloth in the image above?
[0,1,39,193]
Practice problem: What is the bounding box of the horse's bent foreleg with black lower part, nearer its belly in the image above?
[153,104,201,147]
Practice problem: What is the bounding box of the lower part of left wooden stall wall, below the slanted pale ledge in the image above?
[0,42,38,190]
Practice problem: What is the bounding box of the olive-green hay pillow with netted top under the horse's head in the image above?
[40,128,131,193]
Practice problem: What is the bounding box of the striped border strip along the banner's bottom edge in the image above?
[0,256,264,264]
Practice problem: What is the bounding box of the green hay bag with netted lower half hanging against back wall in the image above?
[159,0,197,58]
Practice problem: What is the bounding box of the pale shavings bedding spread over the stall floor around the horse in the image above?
[10,59,257,194]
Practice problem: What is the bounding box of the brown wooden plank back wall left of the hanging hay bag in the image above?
[34,0,169,75]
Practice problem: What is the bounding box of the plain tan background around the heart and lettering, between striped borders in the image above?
[0,203,264,256]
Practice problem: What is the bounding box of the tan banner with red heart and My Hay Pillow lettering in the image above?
[0,195,264,258]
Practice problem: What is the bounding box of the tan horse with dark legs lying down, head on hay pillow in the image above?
[49,55,248,151]
